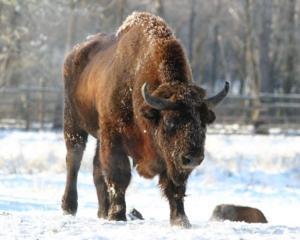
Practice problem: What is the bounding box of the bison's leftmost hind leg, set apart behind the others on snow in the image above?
[61,118,88,215]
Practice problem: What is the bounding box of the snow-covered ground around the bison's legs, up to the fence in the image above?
[0,131,300,240]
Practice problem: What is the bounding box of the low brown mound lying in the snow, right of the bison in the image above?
[211,204,268,223]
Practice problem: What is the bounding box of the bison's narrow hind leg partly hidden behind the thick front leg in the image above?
[93,141,109,218]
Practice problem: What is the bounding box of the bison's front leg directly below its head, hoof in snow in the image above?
[159,173,191,228]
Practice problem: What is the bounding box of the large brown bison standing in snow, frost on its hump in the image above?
[62,13,229,227]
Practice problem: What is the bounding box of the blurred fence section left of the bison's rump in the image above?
[0,87,63,130]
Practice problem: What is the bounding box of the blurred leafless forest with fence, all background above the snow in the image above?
[0,0,300,129]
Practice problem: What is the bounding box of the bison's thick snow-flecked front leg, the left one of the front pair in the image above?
[100,131,131,221]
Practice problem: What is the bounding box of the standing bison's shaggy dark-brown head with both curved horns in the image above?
[142,82,229,182]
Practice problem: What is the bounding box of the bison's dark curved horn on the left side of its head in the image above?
[142,83,179,110]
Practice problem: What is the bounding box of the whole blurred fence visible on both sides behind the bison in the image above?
[0,87,300,133]
